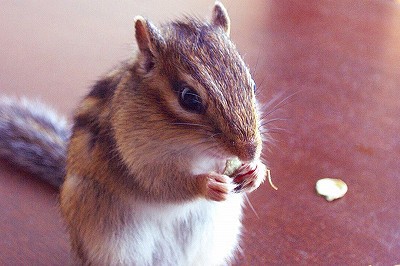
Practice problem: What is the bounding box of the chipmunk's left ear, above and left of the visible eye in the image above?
[135,16,164,70]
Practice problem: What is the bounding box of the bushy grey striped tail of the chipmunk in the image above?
[0,97,71,187]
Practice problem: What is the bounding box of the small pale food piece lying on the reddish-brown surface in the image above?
[315,178,347,201]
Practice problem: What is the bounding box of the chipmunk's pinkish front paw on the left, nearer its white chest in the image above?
[203,173,235,201]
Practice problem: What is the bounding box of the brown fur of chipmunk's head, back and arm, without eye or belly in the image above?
[61,2,261,263]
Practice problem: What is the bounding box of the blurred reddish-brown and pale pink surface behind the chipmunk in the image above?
[0,0,400,265]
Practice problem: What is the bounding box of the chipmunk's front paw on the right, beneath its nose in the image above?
[233,162,267,193]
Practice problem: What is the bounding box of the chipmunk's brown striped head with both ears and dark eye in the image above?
[114,2,262,172]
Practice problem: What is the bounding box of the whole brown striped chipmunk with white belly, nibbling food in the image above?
[0,2,268,265]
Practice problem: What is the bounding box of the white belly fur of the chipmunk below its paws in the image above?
[91,194,242,265]
